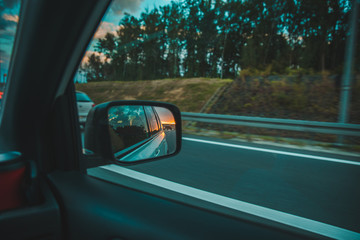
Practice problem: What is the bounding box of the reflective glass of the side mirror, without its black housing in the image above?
[108,105,176,162]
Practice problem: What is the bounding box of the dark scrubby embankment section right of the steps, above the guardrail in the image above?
[208,75,360,123]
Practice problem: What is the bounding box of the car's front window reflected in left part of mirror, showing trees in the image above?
[109,106,149,155]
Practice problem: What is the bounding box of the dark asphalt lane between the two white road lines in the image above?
[128,136,360,232]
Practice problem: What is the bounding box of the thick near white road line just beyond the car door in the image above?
[100,164,360,240]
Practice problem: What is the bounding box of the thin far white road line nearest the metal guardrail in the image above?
[182,137,360,166]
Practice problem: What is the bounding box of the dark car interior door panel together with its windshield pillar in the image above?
[0,0,338,239]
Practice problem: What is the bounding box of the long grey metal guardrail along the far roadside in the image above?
[181,112,360,137]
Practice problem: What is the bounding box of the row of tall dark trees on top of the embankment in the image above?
[82,0,360,81]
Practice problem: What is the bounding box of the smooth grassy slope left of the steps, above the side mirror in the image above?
[76,78,232,112]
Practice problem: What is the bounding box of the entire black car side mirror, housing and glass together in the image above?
[83,101,181,167]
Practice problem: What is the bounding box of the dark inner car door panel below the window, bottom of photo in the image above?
[49,172,316,239]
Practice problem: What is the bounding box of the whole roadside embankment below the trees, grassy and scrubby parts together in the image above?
[76,76,360,123]
